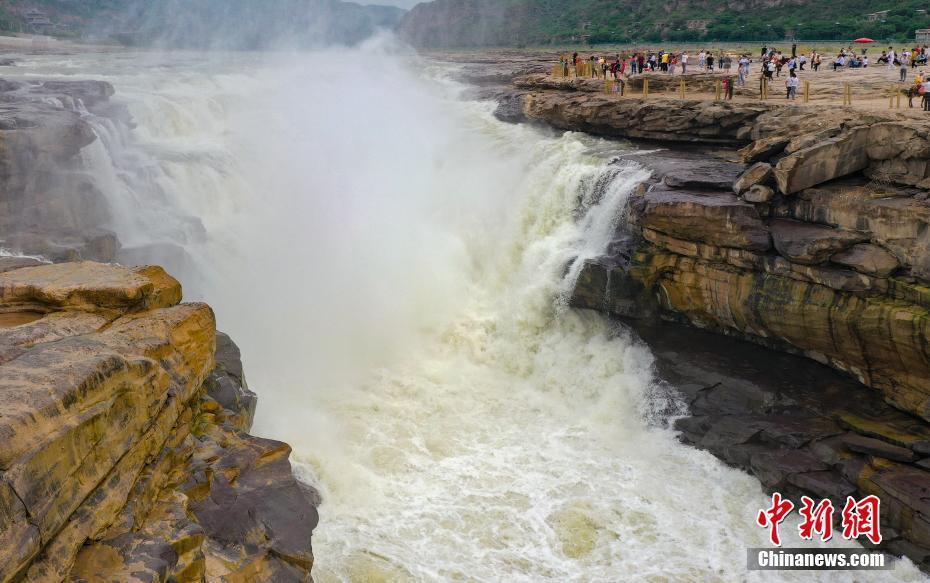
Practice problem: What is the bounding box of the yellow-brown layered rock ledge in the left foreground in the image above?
[0,258,318,582]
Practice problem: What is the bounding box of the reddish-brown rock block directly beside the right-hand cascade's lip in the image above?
[633,191,772,251]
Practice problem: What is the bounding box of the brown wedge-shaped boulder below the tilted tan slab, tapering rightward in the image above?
[771,219,868,265]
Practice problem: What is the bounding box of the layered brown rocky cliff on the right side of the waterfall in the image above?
[503,77,930,569]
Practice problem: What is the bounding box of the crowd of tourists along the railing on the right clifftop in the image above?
[560,44,930,111]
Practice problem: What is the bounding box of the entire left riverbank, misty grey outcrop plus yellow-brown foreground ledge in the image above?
[0,63,319,582]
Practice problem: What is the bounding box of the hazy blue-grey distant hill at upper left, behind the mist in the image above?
[0,0,405,49]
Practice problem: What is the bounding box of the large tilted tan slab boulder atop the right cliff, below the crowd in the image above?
[775,127,869,194]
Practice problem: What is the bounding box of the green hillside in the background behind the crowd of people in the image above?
[399,0,930,47]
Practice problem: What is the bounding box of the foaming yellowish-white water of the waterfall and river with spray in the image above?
[12,41,918,582]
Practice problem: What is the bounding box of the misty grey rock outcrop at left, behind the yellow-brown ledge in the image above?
[0,79,127,261]
